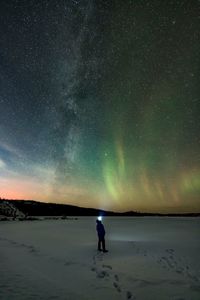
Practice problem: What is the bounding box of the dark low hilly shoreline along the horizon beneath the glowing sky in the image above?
[0,198,200,220]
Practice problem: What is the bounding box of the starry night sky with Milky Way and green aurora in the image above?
[0,0,200,212]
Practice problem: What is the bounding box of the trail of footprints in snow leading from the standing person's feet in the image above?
[91,253,136,300]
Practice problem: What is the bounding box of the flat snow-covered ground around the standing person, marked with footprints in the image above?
[0,217,200,300]
